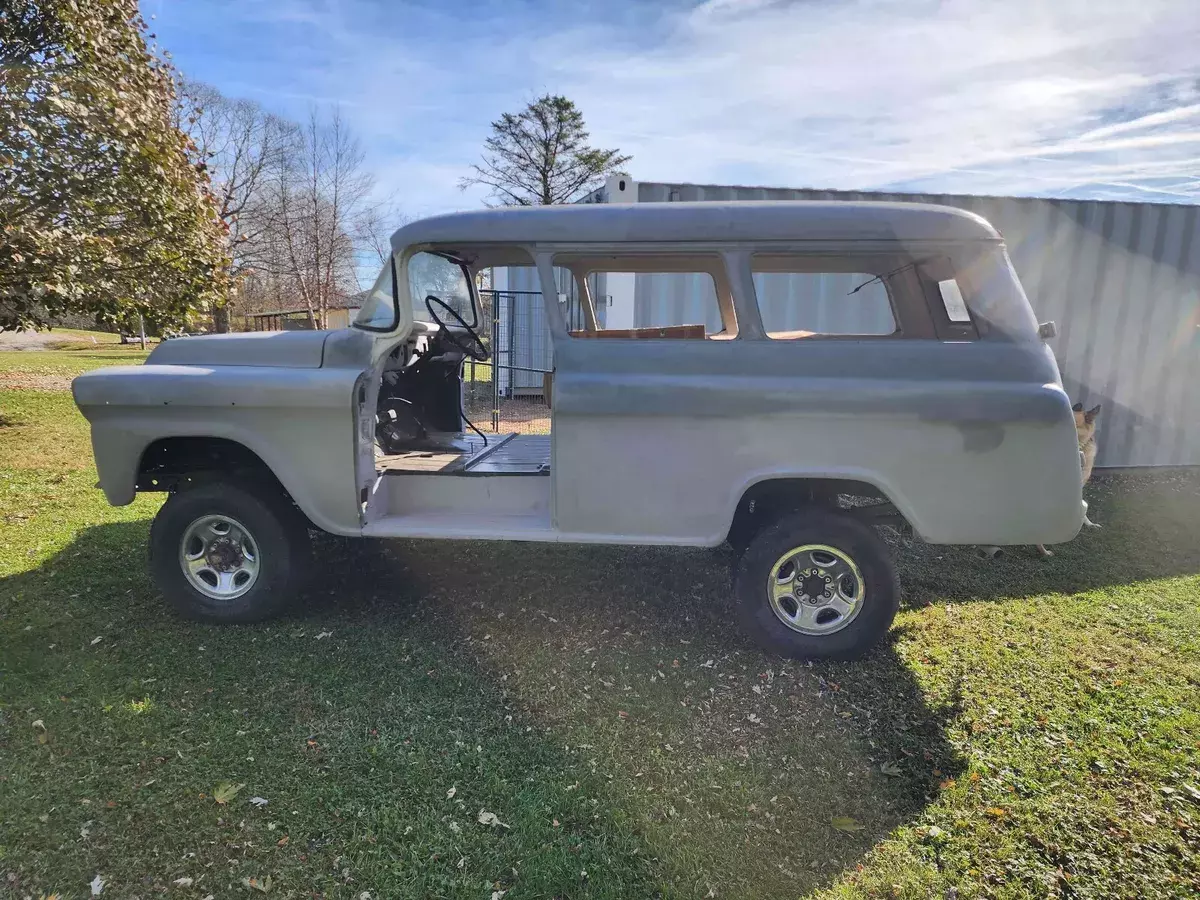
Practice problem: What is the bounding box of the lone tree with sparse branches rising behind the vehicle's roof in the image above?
[460,95,632,206]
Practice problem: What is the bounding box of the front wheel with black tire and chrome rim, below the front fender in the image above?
[150,480,310,623]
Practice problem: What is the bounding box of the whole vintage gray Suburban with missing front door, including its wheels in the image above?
[73,203,1084,655]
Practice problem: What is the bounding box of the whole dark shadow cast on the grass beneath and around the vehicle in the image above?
[9,468,1200,896]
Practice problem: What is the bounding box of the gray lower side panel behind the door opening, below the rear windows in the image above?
[553,340,1082,545]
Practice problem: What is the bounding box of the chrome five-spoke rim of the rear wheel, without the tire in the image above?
[767,544,866,635]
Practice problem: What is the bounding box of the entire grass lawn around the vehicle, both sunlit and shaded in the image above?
[0,352,1200,900]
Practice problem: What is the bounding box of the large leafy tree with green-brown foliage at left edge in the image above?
[0,0,228,325]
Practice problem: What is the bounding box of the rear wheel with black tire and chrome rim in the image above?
[734,509,900,660]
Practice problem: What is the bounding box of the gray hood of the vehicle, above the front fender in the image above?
[146,331,332,368]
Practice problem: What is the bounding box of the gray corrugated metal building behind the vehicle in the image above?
[496,181,1200,467]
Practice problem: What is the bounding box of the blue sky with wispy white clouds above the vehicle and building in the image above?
[142,0,1200,216]
